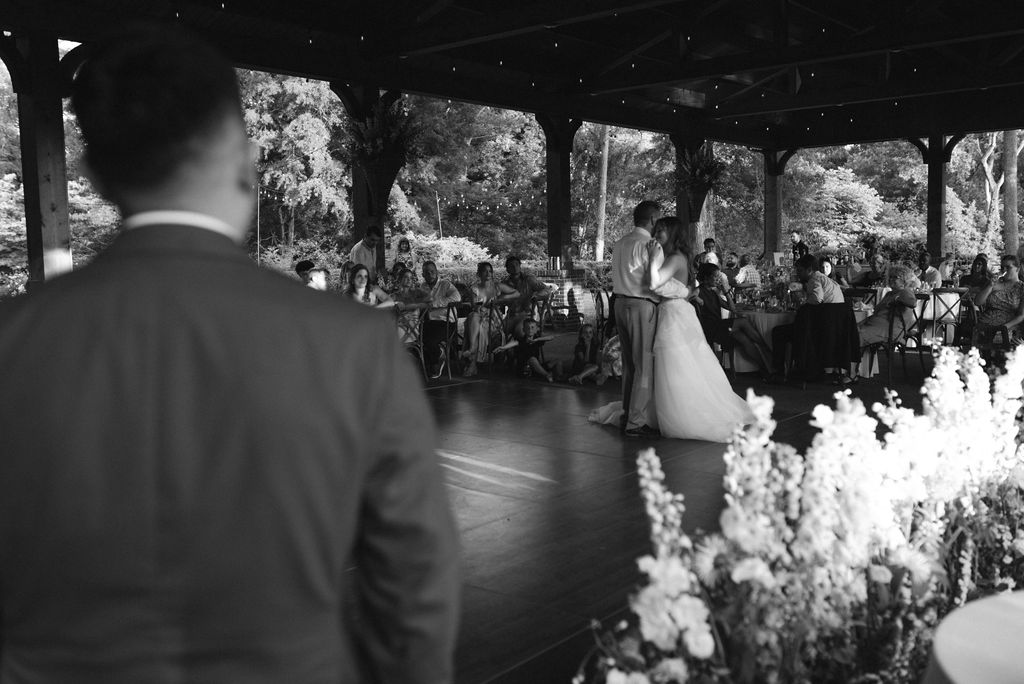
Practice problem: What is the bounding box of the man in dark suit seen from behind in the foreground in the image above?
[0,26,459,684]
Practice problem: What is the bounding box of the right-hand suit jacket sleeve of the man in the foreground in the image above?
[354,321,460,684]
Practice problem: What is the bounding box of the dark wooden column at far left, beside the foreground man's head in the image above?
[3,33,72,288]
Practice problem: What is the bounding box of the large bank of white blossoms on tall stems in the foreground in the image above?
[575,348,1024,684]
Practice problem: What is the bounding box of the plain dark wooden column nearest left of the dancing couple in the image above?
[537,114,583,265]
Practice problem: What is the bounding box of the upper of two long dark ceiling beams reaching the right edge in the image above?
[587,12,1024,94]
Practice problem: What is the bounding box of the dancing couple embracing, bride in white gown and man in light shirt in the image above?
[590,201,754,441]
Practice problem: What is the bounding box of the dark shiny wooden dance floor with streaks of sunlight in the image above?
[427,356,922,684]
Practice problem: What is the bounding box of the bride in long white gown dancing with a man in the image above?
[590,216,754,441]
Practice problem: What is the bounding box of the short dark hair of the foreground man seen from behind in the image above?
[72,26,242,188]
